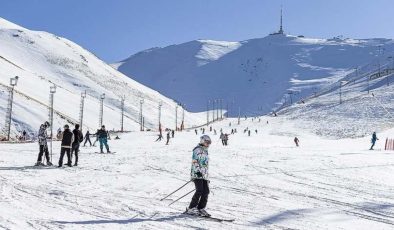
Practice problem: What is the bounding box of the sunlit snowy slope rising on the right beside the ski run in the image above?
[278,56,394,138]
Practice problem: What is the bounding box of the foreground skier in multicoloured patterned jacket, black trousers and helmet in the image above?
[186,135,212,217]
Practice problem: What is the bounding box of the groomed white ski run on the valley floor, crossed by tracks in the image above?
[0,118,394,229]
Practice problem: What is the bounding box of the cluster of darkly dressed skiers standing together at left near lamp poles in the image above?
[35,121,110,167]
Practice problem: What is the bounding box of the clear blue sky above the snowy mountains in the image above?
[0,0,394,62]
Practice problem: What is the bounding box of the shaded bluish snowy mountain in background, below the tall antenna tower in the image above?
[112,34,394,117]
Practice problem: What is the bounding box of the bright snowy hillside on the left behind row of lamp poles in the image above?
[0,18,206,136]
